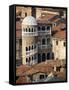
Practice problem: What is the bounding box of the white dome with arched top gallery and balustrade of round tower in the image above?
[22,16,38,36]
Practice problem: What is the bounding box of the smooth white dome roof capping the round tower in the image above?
[22,16,37,25]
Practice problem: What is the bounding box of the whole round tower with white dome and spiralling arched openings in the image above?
[22,16,38,65]
